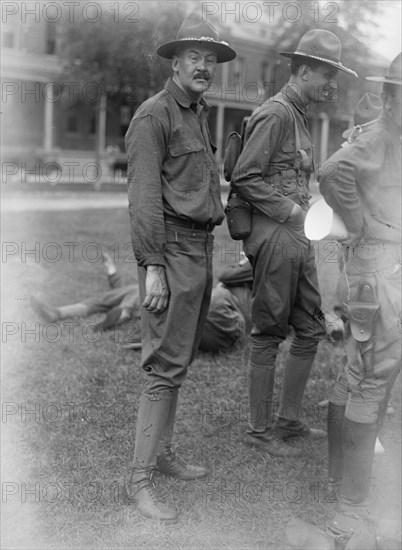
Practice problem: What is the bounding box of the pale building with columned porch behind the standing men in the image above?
[2,2,387,183]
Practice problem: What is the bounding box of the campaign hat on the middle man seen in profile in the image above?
[279,29,357,77]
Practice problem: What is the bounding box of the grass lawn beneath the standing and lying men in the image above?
[2,199,401,550]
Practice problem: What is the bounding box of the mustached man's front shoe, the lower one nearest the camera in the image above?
[126,468,178,523]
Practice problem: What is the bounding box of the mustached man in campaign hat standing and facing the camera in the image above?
[126,14,236,522]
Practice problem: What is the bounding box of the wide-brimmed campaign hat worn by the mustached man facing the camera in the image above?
[156,13,236,63]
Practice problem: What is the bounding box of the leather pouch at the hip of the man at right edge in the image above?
[344,281,380,342]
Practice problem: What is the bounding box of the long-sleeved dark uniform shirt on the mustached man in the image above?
[126,78,224,266]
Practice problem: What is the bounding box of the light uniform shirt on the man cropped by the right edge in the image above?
[318,113,401,243]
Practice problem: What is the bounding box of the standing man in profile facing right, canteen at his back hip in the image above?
[231,29,357,457]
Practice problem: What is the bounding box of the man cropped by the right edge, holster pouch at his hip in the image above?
[318,54,402,535]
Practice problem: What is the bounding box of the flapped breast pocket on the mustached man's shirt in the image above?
[166,139,209,191]
